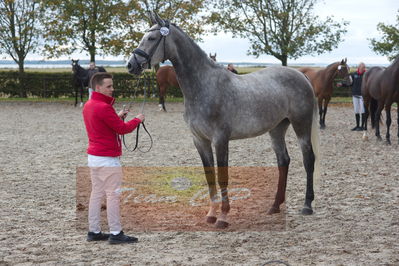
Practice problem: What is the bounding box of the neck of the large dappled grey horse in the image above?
[170,28,218,100]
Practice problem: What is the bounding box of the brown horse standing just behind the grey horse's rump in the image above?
[298,58,351,129]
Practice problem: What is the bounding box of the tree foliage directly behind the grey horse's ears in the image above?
[115,0,211,56]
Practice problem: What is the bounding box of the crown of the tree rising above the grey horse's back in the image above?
[209,0,348,66]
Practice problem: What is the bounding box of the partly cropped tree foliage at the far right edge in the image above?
[369,10,399,61]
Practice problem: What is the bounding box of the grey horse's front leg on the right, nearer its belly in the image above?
[215,139,230,229]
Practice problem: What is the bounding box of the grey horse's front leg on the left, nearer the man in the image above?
[194,137,219,223]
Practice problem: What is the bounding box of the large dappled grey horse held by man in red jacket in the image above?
[127,14,319,228]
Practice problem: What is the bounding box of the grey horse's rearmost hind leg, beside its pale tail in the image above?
[292,119,315,215]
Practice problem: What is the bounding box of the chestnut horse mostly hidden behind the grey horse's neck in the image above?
[156,53,216,112]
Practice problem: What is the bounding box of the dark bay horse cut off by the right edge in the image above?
[362,56,399,144]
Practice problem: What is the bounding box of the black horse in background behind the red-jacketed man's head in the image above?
[72,59,107,107]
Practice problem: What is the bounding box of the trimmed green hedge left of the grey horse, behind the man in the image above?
[0,71,183,98]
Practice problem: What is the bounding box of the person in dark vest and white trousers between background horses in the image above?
[337,62,366,131]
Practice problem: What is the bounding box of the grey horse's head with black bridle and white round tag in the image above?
[127,13,170,75]
